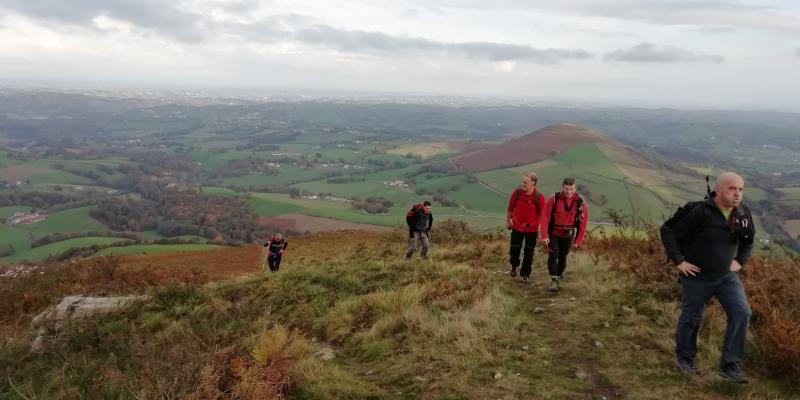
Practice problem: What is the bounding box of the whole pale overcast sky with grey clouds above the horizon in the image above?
[0,0,800,112]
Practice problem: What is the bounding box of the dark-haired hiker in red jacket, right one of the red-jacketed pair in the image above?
[539,177,589,292]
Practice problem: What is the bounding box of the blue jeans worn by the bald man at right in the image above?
[675,272,752,367]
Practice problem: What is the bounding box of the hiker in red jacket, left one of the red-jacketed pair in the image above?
[506,172,545,283]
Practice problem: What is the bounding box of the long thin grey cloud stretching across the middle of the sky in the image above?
[294,25,593,64]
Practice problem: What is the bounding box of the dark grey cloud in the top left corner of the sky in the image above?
[0,0,209,42]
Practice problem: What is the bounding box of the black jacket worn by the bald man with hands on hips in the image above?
[661,199,753,280]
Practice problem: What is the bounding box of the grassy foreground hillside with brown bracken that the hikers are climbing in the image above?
[0,229,798,399]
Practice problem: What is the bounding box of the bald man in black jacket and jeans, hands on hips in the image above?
[661,172,755,383]
